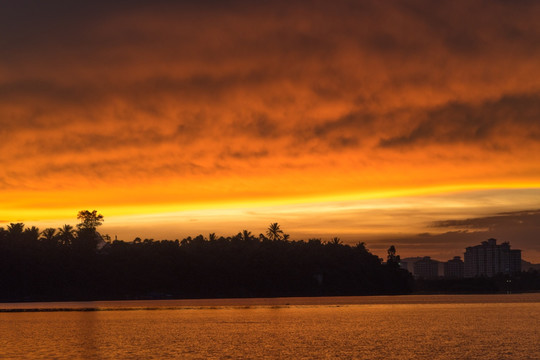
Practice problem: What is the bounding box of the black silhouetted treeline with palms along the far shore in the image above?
[0,211,413,301]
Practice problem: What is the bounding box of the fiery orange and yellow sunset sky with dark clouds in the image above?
[0,0,540,262]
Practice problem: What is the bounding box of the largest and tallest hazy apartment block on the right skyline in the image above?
[464,239,521,277]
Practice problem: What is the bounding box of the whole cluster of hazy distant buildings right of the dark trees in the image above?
[400,239,521,279]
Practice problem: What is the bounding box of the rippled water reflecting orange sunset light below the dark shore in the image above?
[0,294,540,360]
